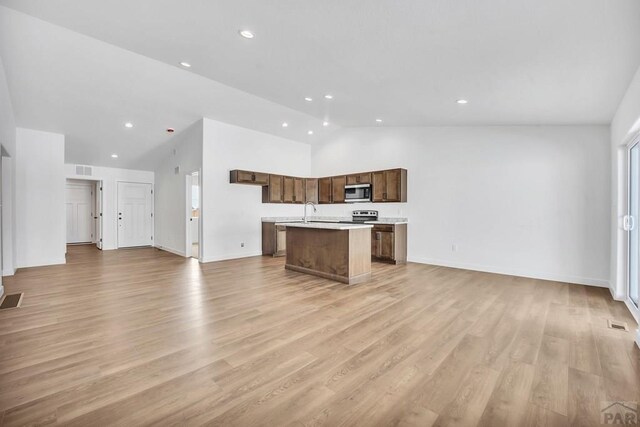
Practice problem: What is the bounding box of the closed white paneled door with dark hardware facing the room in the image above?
[118,182,153,248]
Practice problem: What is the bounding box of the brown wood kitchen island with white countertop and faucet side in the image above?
[280,222,373,284]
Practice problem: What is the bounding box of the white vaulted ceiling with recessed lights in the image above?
[0,0,640,169]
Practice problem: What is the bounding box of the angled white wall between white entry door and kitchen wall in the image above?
[154,120,203,256]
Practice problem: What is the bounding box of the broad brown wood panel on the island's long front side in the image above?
[285,227,350,283]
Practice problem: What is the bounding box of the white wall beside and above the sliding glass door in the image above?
[610,68,640,299]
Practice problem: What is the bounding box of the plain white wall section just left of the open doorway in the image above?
[15,128,66,268]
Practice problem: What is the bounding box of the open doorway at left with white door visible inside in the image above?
[65,179,102,249]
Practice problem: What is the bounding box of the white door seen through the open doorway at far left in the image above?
[65,182,94,243]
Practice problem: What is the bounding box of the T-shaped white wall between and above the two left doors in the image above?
[64,164,154,250]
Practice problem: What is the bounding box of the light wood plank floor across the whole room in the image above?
[0,246,640,427]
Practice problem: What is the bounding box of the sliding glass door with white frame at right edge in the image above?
[624,135,640,318]
